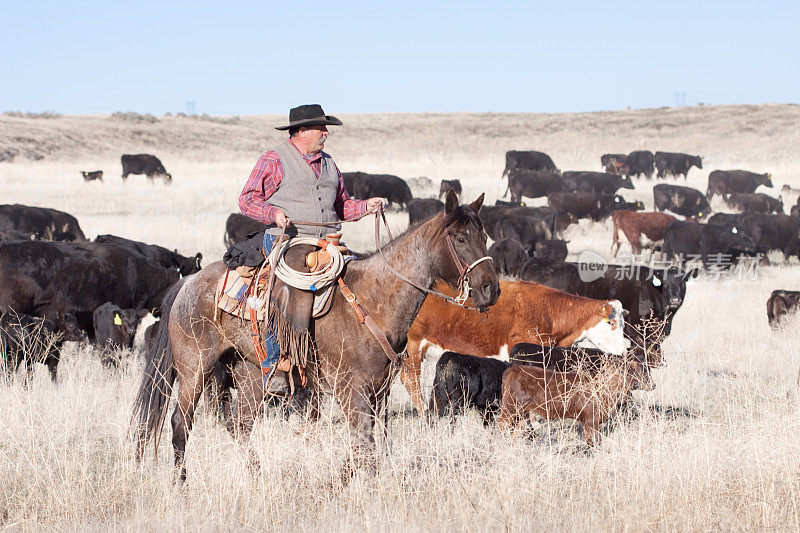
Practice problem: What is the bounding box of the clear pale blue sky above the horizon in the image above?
[0,0,800,114]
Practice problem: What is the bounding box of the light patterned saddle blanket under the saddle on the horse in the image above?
[214,270,336,321]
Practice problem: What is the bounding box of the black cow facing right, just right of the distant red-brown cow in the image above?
[661,220,757,269]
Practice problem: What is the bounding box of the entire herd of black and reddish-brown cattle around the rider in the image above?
[0,145,800,454]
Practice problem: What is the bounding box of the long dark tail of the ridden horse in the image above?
[131,278,187,459]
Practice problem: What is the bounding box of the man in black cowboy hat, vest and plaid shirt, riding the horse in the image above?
[239,104,386,392]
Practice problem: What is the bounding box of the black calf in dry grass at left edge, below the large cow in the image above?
[0,310,86,381]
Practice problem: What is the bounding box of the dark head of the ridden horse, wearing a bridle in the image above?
[435,189,500,309]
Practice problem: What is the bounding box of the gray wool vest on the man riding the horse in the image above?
[267,140,342,237]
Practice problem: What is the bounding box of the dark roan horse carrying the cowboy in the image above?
[133,191,500,483]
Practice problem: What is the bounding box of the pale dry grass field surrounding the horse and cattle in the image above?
[0,105,800,531]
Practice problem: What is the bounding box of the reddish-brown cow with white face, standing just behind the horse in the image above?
[401,280,629,413]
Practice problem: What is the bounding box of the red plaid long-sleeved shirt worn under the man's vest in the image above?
[239,140,367,225]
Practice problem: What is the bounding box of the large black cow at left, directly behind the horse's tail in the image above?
[0,241,179,366]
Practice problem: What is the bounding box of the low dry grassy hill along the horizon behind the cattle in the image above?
[0,104,800,166]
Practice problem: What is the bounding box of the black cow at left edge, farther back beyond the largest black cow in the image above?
[0,204,86,241]
